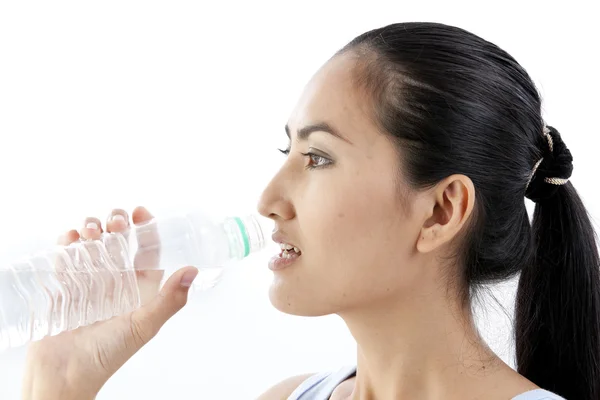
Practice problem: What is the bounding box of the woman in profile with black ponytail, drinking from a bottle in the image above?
[24,23,600,400]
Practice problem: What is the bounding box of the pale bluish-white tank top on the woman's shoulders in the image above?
[288,367,565,400]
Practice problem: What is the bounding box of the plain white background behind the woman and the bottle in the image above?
[0,0,600,400]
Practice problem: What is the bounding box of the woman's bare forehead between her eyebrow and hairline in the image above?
[288,55,377,142]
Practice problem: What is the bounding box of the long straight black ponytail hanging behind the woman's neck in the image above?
[515,130,600,400]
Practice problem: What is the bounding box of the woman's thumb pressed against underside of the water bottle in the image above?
[131,267,198,349]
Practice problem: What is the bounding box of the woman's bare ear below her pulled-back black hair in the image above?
[417,175,475,253]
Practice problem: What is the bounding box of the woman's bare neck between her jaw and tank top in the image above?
[340,282,506,400]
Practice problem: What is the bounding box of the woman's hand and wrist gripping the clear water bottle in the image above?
[23,207,198,400]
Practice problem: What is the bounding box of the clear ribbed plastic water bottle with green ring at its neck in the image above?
[0,212,270,351]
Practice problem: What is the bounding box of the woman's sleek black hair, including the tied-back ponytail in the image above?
[337,23,600,400]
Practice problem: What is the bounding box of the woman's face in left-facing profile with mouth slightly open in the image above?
[259,56,422,316]
